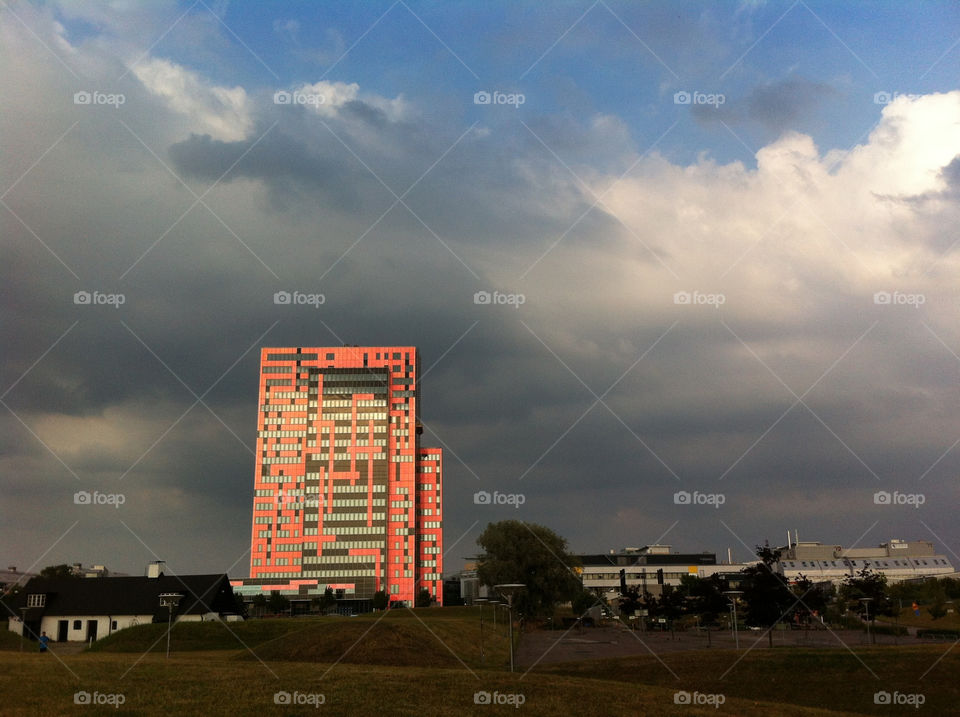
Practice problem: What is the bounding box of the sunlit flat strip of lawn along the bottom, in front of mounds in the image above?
[0,652,852,717]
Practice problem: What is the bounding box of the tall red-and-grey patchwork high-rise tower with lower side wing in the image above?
[244,346,443,606]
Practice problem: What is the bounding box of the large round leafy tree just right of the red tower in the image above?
[477,520,583,617]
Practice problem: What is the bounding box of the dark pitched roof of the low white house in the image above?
[8,574,234,620]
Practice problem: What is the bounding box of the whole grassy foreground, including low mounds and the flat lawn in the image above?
[0,608,960,717]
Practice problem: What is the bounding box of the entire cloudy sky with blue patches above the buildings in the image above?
[0,0,960,577]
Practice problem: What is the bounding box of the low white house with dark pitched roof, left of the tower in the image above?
[8,571,237,642]
